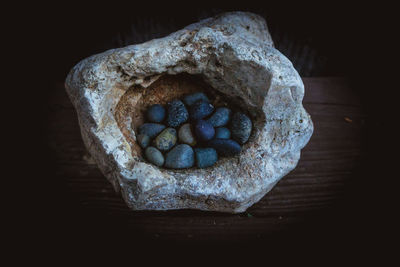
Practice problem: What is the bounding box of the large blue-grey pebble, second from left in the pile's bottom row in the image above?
[165,144,194,169]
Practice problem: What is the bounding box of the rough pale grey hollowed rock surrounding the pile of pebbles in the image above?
[65,12,313,213]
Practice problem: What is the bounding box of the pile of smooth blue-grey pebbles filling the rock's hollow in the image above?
[137,93,252,169]
